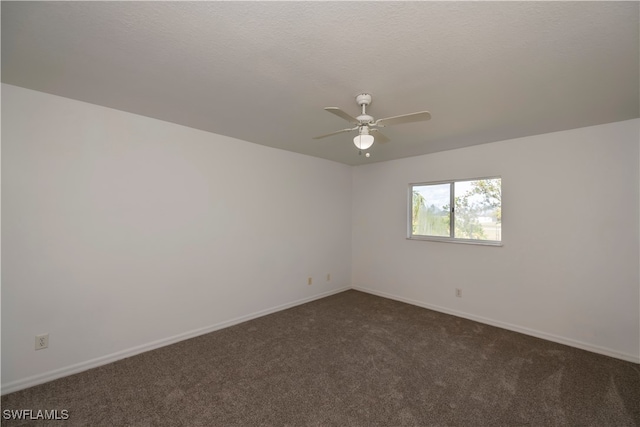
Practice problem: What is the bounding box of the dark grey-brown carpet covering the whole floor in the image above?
[2,291,640,426]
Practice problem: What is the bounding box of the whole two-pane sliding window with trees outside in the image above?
[409,178,502,245]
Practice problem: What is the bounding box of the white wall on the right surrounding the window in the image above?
[352,119,640,362]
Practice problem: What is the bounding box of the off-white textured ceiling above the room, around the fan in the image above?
[1,1,640,165]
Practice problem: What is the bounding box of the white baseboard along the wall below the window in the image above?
[351,286,640,363]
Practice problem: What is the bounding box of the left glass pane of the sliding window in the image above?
[411,184,451,237]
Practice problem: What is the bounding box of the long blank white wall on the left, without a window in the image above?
[2,85,351,393]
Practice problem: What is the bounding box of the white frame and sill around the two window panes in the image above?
[407,176,504,246]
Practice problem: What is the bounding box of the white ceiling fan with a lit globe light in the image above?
[313,93,431,155]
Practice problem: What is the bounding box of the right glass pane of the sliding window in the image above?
[454,178,502,241]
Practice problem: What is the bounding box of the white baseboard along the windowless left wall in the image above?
[1,287,350,395]
